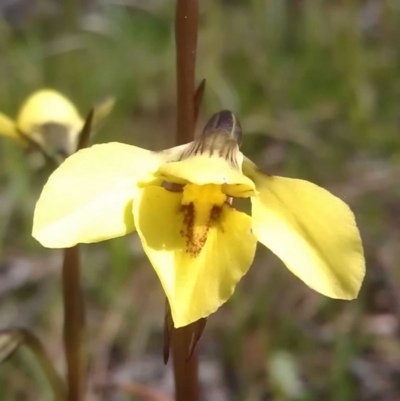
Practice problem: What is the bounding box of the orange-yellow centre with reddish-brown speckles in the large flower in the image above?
[181,184,229,258]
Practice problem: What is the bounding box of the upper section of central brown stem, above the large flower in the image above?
[175,0,199,145]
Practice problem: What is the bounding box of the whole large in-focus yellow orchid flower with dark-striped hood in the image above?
[33,111,365,327]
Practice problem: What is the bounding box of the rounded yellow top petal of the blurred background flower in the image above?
[17,89,83,135]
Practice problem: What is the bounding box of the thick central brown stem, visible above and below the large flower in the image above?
[171,0,199,401]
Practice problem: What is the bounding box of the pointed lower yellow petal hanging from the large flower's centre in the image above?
[134,186,257,327]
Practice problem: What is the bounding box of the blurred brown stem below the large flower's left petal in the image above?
[62,246,86,401]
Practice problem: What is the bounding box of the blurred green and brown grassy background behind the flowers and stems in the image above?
[0,0,400,401]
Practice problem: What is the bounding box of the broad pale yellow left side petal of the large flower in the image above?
[33,143,159,248]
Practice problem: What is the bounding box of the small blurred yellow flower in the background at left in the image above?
[0,89,114,158]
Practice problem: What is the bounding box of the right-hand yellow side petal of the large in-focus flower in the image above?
[252,168,365,299]
